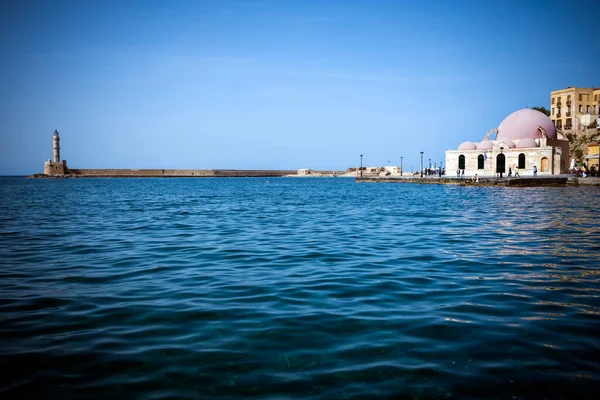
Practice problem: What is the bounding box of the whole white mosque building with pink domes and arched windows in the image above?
[446,108,570,177]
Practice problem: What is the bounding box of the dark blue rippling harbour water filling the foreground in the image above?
[0,178,600,399]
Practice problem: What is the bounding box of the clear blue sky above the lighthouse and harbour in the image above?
[0,0,600,174]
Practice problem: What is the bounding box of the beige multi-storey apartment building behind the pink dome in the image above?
[550,86,600,133]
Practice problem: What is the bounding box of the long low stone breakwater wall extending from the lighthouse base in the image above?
[30,168,297,178]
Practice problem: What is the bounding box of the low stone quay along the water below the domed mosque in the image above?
[356,176,600,187]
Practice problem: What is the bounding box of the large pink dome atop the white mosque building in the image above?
[496,108,556,141]
